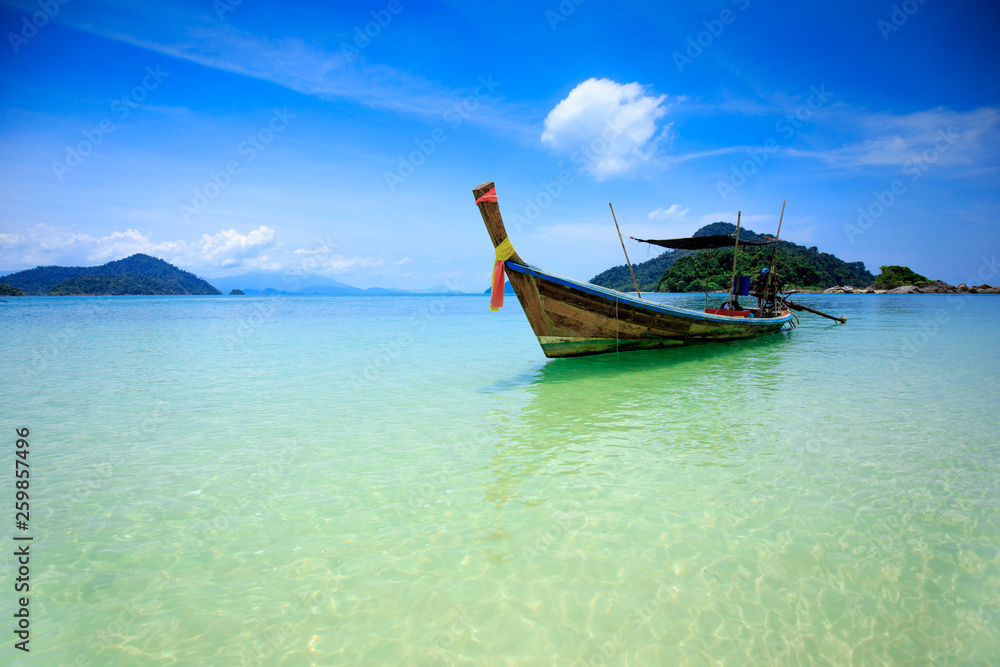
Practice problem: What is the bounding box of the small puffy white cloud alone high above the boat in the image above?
[542,79,669,180]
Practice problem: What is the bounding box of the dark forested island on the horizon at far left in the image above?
[0,253,221,296]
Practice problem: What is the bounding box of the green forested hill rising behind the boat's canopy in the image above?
[590,222,875,292]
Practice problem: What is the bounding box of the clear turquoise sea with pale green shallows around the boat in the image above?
[0,295,1000,665]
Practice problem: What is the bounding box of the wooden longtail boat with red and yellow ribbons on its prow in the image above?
[472,183,794,357]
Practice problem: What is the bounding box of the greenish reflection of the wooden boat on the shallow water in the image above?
[479,332,795,565]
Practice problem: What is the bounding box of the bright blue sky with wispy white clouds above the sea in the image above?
[0,0,1000,291]
